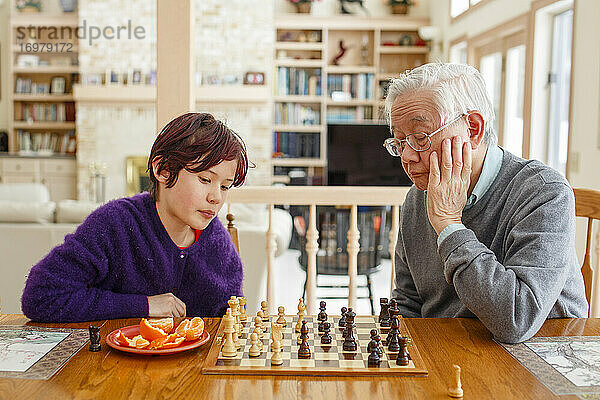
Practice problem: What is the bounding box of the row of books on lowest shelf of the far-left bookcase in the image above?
[17,129,77,155]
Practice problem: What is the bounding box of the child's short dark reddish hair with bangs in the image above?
[148,113,248,201]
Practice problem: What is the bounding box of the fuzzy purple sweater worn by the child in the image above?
[21,193,243,322]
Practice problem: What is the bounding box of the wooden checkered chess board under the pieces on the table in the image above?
[202,315,427,376]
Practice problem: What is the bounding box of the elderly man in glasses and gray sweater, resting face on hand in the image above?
[384,63,588,343]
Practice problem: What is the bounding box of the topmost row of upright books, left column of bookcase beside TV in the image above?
[276,67,321,96]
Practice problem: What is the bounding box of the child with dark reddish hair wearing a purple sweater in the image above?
[22,113,248,322]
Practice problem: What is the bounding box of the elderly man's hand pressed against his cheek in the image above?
[427,136,471,235]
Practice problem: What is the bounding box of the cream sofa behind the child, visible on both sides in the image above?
[0,183,292,314]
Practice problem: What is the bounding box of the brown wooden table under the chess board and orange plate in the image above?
[0,315,600,400]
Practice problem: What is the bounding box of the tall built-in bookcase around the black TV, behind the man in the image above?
[272,14,429,184]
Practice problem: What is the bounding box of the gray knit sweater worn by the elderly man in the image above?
[393,151,588,343]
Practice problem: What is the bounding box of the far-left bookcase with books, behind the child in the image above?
[8,5,79,159]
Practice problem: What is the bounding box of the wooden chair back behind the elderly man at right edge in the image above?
[573,189,600,307]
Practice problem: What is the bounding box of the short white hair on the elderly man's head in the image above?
[385,63,498,144]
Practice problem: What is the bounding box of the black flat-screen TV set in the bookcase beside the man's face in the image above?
[327,124,412,186]
